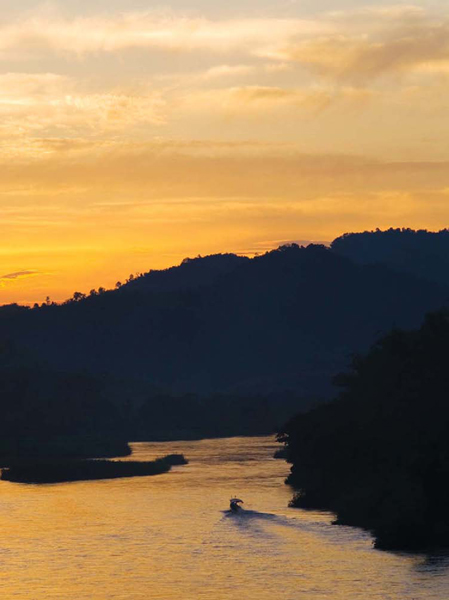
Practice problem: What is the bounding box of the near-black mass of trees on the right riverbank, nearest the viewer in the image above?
[280,311,449,549]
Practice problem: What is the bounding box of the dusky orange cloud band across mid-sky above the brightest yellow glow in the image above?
[0,139,449,202]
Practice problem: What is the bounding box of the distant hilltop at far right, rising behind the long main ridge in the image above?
[331,229,449,286]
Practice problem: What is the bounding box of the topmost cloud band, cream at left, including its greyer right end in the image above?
[0,6,449,85]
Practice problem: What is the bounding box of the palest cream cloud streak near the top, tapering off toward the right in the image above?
[0,12,329,58]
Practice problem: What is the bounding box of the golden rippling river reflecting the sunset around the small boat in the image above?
[0,437,449,600]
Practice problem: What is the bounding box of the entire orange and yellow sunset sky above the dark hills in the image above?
[0,0,449,304]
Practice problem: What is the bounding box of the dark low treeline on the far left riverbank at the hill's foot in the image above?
[0,336,311,448]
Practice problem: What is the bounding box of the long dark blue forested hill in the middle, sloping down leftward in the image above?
[0,245,449,396]
